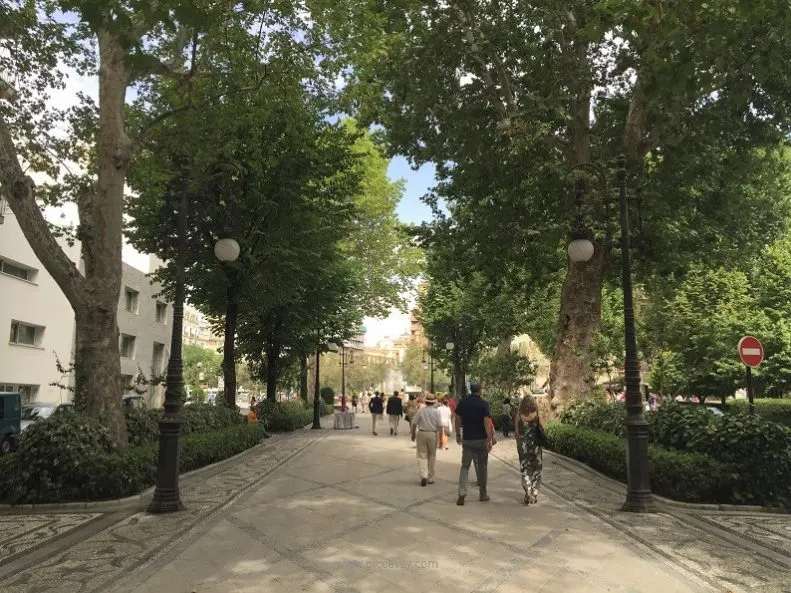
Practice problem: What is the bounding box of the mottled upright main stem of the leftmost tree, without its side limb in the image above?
[74,32,132,449]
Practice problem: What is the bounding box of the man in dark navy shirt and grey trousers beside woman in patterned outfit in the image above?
[456,383,494,506]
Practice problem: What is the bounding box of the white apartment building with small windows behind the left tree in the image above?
[0,200,172,405]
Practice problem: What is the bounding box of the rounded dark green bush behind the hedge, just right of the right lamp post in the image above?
[648,402,717,451]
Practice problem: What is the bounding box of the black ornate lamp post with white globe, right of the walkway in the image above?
[568,155,656,513]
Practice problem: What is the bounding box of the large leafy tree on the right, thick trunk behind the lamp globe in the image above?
[311,0,791,412]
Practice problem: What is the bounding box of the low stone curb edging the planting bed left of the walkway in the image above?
[0,423,330,515]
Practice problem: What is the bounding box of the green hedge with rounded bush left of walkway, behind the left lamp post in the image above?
[0,413,261,504]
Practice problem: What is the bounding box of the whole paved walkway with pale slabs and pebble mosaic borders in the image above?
[0,415,791,593]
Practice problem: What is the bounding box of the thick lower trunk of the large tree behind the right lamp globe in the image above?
[549,241,608,409]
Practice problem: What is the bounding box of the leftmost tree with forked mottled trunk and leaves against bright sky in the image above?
[0,0,286,448]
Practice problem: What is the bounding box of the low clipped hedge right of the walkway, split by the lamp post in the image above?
[546,422,736,503]
